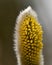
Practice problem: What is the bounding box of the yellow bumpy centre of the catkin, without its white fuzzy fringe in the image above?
[19,15,43,65]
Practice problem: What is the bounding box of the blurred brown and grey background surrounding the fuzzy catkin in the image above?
[0,0,52,65]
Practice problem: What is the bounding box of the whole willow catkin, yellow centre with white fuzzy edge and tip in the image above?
[14,7,44,65]
